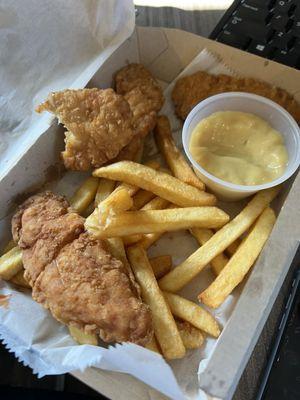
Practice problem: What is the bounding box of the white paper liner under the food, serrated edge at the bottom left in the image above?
[0,42,248,400]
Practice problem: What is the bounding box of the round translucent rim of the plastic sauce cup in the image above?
[182,92,300,193]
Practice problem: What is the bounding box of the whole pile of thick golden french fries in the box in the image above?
[0,116,279,359]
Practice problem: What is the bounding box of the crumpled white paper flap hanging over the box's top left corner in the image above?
[0,0,135,180]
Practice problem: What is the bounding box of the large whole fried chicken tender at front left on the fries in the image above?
[12,192,153,345]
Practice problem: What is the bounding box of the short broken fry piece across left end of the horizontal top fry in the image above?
[85,188,132,237]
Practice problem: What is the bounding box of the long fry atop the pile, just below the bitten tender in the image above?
[93,161,216,207]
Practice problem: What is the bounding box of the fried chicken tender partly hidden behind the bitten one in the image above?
[114,64,164,161]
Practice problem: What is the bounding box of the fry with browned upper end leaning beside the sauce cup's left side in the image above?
[154,115,205,190]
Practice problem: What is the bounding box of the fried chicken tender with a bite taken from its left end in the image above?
[36,89,134,171]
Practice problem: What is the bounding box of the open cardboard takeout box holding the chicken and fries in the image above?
[0,28,300,400]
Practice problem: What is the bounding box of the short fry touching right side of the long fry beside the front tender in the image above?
[163,292,220,337]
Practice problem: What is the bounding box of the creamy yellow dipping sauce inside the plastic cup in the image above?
[189,111,288,185]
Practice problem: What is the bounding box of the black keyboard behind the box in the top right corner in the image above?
[210,0,300,69]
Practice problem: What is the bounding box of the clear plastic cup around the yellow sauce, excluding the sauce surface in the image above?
[182,92,300,201]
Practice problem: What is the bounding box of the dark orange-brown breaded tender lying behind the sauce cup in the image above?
[172,71,300,123]
